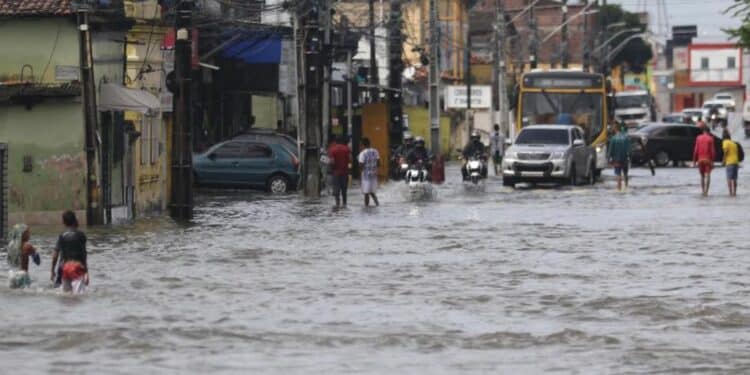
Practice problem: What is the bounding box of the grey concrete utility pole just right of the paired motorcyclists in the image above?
[430,0,440,155]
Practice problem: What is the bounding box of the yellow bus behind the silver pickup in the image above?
[516,70,609,175]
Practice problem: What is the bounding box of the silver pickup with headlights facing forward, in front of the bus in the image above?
[502,125,596,186]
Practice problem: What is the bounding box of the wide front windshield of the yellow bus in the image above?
[521,90,604,143]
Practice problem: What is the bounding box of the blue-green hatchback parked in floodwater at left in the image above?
[193,138,299,193]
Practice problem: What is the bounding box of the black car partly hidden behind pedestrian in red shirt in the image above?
[630,123,723,167]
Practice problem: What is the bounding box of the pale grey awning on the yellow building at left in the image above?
[99,83,161,114]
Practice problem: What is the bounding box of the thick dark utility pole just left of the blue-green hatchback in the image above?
[169,0,194,220]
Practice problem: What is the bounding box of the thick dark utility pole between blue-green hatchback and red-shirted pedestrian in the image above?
[302,3,324,198]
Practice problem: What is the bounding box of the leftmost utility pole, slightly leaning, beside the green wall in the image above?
[77,8,104,225]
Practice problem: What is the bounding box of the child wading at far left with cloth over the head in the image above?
[8,224,41,289]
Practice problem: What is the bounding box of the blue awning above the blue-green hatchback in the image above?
[223,33,281,64]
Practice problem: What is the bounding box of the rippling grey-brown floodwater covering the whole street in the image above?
[0,149,750,374]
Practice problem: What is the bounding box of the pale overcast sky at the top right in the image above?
[608,0,740,42]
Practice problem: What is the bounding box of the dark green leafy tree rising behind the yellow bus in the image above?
[599,4,652,73]
